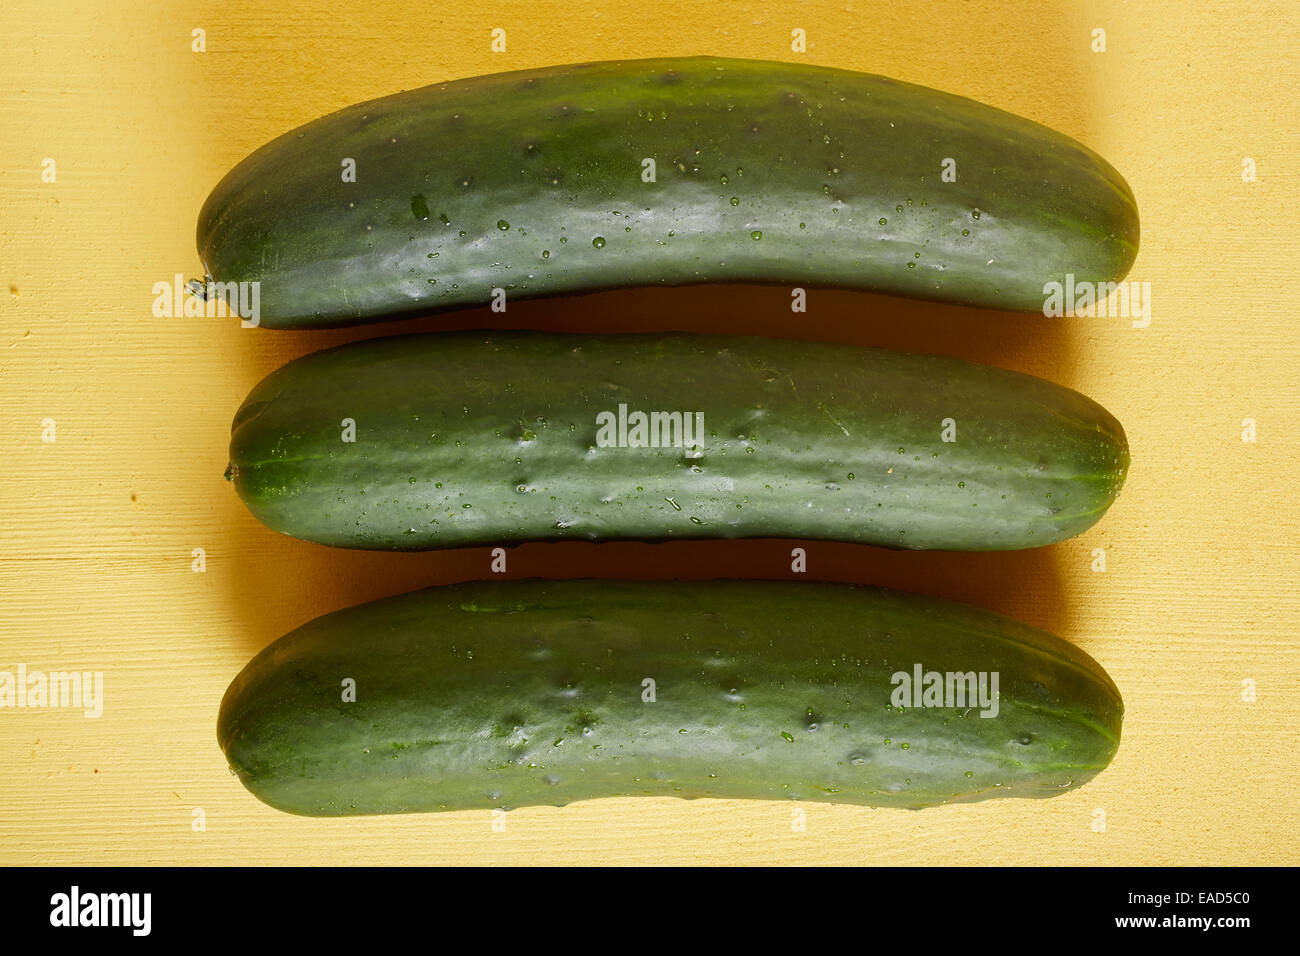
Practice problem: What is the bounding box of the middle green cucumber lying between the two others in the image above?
[226,332,1128,550]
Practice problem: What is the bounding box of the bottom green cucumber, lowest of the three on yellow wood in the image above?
[218,580,1123,816]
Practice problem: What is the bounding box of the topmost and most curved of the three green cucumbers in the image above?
[198,57,1139,328]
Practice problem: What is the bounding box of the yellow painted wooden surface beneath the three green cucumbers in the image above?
[0,0,1300,865]
